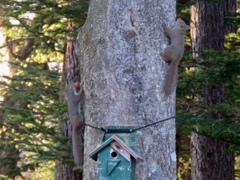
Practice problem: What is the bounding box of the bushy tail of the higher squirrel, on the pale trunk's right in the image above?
[164,62,178,96]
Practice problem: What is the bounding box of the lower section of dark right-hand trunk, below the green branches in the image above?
[191,132,234,180]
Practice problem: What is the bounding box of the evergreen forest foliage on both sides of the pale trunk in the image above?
[0,0,240,179]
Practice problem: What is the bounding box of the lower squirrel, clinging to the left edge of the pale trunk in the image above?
[63,82,84,166]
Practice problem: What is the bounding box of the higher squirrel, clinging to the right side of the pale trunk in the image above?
[160,18,190,96]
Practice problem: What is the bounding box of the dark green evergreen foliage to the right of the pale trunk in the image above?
[176,0,240,179]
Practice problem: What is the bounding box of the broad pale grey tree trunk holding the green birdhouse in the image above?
[78,0,176,180]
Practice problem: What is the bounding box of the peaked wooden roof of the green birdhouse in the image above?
[89,135,143,162]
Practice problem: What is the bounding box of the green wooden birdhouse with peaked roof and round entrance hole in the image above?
[90,135,143,180]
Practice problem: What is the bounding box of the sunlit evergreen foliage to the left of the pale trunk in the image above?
[0,0,88,179]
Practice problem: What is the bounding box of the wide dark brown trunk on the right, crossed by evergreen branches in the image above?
[190,1,234,180]
